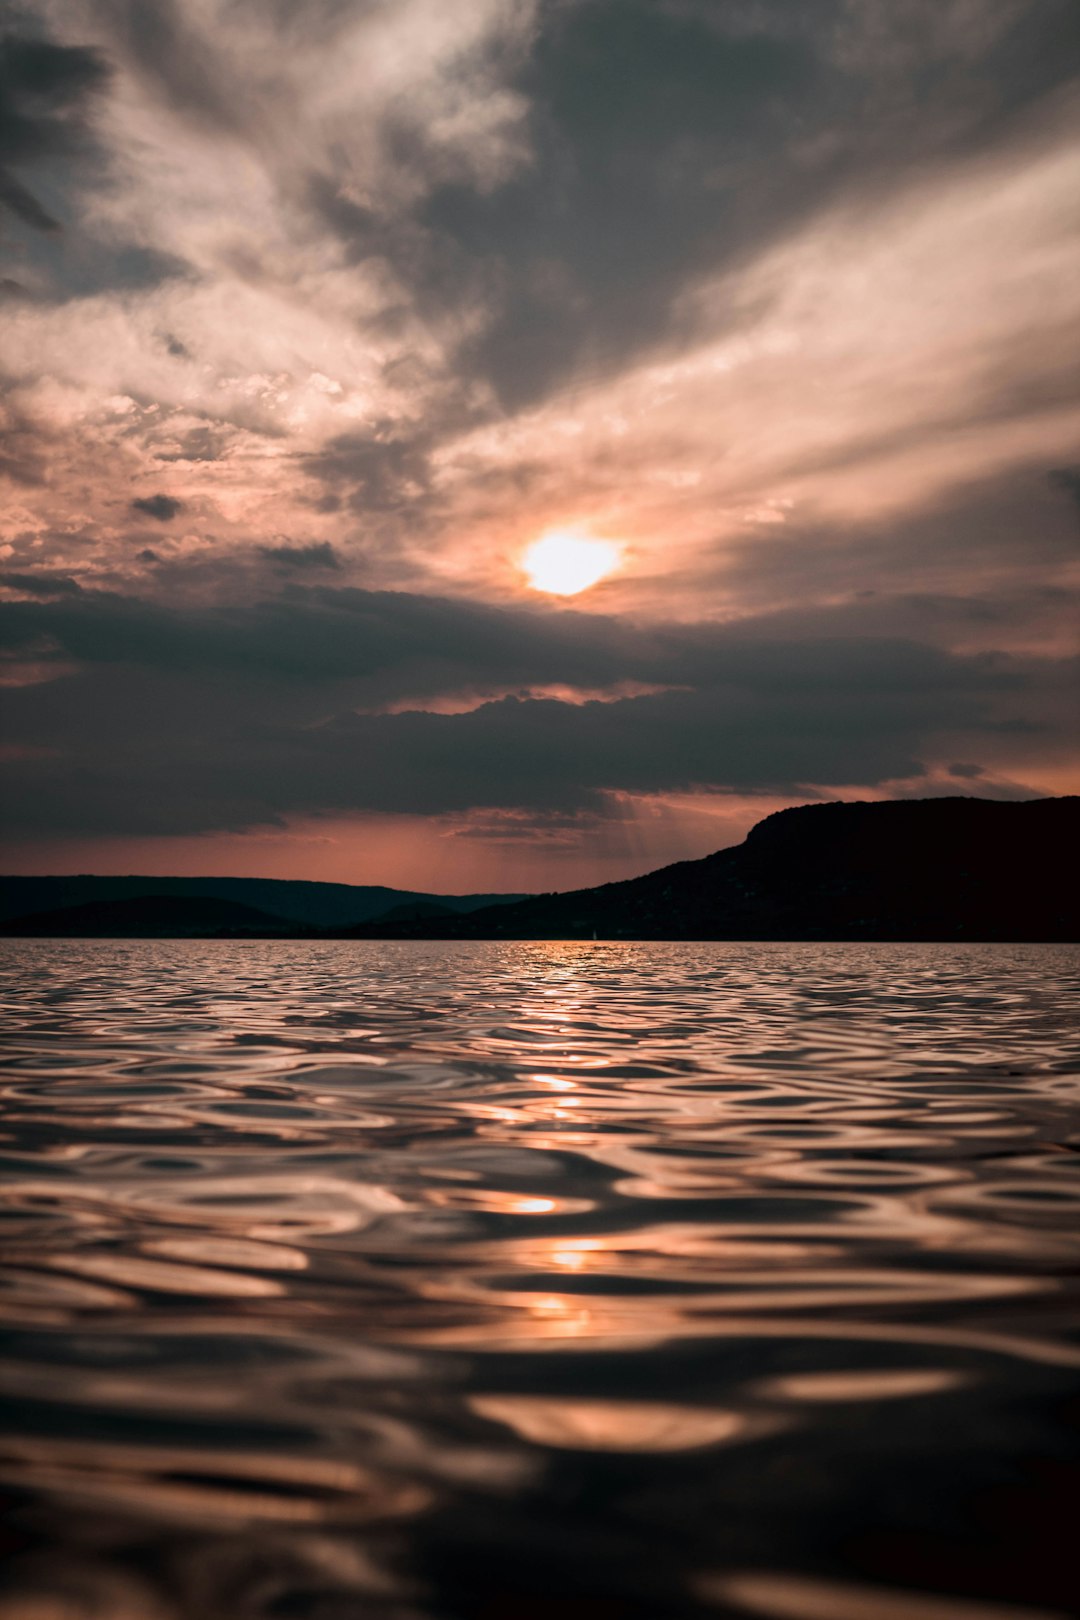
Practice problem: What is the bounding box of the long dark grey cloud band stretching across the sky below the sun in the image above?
[0,590,1067,833]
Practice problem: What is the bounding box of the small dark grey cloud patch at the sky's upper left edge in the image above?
[0,32,108,232]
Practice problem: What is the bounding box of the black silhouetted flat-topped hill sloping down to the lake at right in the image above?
[350,797,1080,940]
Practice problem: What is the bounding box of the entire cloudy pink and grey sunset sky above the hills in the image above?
[0,0,1080,893]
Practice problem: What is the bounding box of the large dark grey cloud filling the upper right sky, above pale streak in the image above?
[352,0,1080,408]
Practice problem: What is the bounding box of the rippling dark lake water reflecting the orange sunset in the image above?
[0,941,1080,1620]
